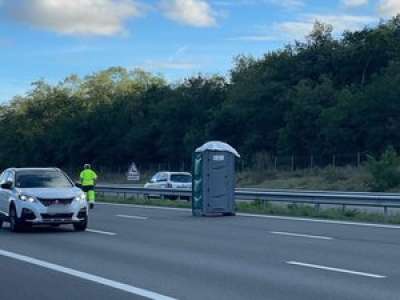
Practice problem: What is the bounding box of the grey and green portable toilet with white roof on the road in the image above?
[192,142,240,216]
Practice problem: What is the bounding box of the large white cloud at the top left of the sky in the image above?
[8,0,141,35]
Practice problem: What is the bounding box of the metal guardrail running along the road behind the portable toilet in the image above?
[96,185,400,216]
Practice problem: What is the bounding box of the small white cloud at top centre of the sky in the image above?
[160,0,217,27]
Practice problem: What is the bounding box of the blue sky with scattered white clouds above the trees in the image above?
[0,0,400,102]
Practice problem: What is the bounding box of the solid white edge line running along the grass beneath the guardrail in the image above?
[97,202,400,229]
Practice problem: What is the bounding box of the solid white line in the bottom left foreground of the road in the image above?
[0,249,176,300]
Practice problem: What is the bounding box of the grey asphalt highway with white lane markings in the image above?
[0,204,400,300]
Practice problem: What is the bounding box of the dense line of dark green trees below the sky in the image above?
[0,16,400,171]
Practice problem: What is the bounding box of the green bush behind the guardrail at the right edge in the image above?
[367,147,400,192]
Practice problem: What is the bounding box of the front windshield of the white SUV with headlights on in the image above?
[15,171,72,188]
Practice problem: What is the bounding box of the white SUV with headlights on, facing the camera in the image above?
[0,168,88,232]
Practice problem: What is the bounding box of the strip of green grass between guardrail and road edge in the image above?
[98,195,400,224]
